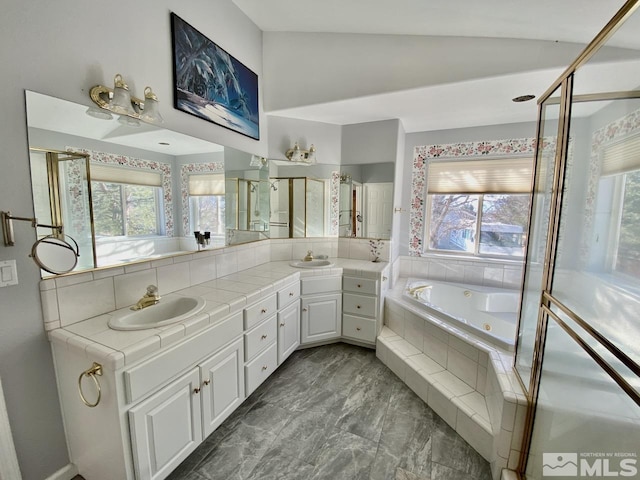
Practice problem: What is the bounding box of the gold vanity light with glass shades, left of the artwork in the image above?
[87,73,164,126]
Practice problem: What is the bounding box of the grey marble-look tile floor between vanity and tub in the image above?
[168,343,491,480]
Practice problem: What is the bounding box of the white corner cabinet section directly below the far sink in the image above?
[300,276,342,345]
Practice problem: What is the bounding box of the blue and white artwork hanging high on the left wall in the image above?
[171,13,260,140]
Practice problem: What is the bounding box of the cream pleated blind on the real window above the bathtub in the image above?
[427,158,533,194]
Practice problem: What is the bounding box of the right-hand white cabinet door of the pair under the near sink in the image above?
[200,339,244,438]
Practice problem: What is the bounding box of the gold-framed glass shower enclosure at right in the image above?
[515,0,640,479]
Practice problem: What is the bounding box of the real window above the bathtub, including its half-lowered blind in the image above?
[426,158,532,257]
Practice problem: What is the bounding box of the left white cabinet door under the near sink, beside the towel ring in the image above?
[129,368,202,480]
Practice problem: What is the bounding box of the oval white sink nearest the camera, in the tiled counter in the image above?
[109,296,205,330]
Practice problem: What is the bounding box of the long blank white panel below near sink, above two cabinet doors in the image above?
[124,312,242,403]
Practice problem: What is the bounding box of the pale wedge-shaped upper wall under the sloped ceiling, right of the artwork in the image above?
[264,32,640,112]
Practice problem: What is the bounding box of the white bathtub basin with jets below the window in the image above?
[403,278,520,351]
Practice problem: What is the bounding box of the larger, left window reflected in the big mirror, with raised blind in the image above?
[91,165,163,237]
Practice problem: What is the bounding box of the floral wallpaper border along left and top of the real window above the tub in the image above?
[409,138,536,257]
